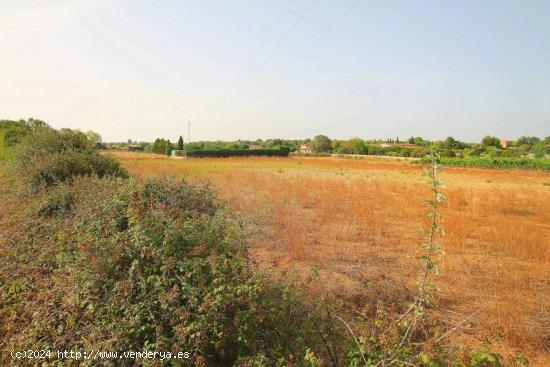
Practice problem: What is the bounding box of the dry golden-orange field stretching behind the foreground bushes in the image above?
[112,152,550,365]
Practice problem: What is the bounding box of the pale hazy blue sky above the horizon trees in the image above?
[0,0,550,141]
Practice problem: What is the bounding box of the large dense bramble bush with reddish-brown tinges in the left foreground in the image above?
[0,178,326,366]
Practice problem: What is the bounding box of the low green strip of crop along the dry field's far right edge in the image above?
[413,157,550,170]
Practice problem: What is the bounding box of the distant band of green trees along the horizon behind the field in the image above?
[0,118,550,158]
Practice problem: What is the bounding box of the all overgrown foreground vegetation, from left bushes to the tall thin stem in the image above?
[0,126,544,367]
